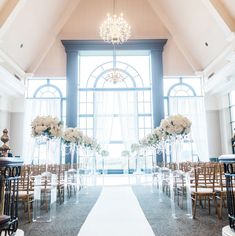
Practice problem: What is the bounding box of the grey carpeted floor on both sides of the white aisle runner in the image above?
[19,185,228,236]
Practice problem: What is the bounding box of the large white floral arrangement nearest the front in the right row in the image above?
[160,115,192,136]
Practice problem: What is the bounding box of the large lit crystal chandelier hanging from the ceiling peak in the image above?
[100,0,131,44]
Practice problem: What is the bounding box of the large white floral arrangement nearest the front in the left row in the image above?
[31,116,63,139]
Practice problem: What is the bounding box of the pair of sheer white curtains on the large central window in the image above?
[94,91,138,151]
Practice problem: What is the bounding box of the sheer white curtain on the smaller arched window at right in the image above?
[169,97,209,161]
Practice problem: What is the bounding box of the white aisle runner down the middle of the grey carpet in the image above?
[78,187,154,236]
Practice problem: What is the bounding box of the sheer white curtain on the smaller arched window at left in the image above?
[23,99,61,164]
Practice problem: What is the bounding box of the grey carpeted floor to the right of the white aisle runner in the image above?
[132,186,228,236]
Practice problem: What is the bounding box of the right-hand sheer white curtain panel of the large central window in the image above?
[117,91,138,151]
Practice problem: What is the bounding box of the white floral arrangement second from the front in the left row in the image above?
[61,128,83,146]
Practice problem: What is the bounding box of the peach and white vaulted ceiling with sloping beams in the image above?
[0,0,235,93]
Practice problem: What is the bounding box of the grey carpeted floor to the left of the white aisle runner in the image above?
[19,187,102,236]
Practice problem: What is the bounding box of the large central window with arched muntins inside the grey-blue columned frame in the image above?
[78,51,152,168]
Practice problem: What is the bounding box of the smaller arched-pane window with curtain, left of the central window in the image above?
[23,78,66,164]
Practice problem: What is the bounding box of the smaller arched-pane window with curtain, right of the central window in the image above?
[164,77,209,161]
